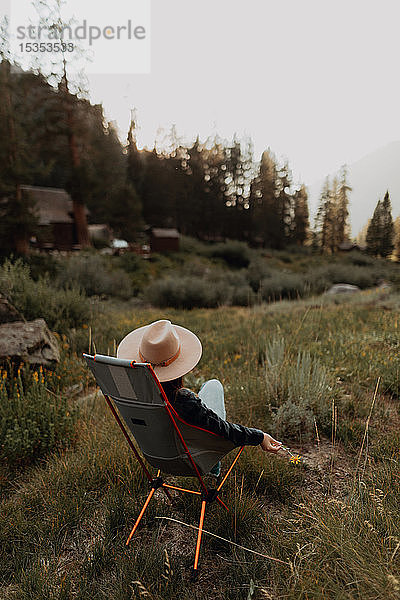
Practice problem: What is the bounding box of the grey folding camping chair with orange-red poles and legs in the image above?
[83,354,244,576]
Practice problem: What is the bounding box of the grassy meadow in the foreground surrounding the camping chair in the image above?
[0,251,400,600]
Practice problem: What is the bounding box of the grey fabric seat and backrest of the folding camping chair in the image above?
[83,354,235,476]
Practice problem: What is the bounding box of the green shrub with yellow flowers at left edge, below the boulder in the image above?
[0,368,77,466]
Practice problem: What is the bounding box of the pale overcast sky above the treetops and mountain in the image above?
[3,0,400,184]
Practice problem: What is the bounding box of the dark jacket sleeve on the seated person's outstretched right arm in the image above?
[173,388,264,446]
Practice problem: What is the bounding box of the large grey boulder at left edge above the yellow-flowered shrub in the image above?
[0,319,60,367]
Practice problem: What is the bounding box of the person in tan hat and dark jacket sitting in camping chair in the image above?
[117,320,282,476]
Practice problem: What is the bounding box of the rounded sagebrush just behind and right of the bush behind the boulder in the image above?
[57,253,132,299]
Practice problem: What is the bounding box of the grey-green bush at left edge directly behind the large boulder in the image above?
[0,259,90,332]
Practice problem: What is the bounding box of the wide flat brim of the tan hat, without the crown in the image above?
[117,324,203,381]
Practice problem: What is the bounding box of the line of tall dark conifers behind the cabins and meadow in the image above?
[0,56,393,256]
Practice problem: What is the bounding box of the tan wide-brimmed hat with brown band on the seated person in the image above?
[117,319,202,381]
